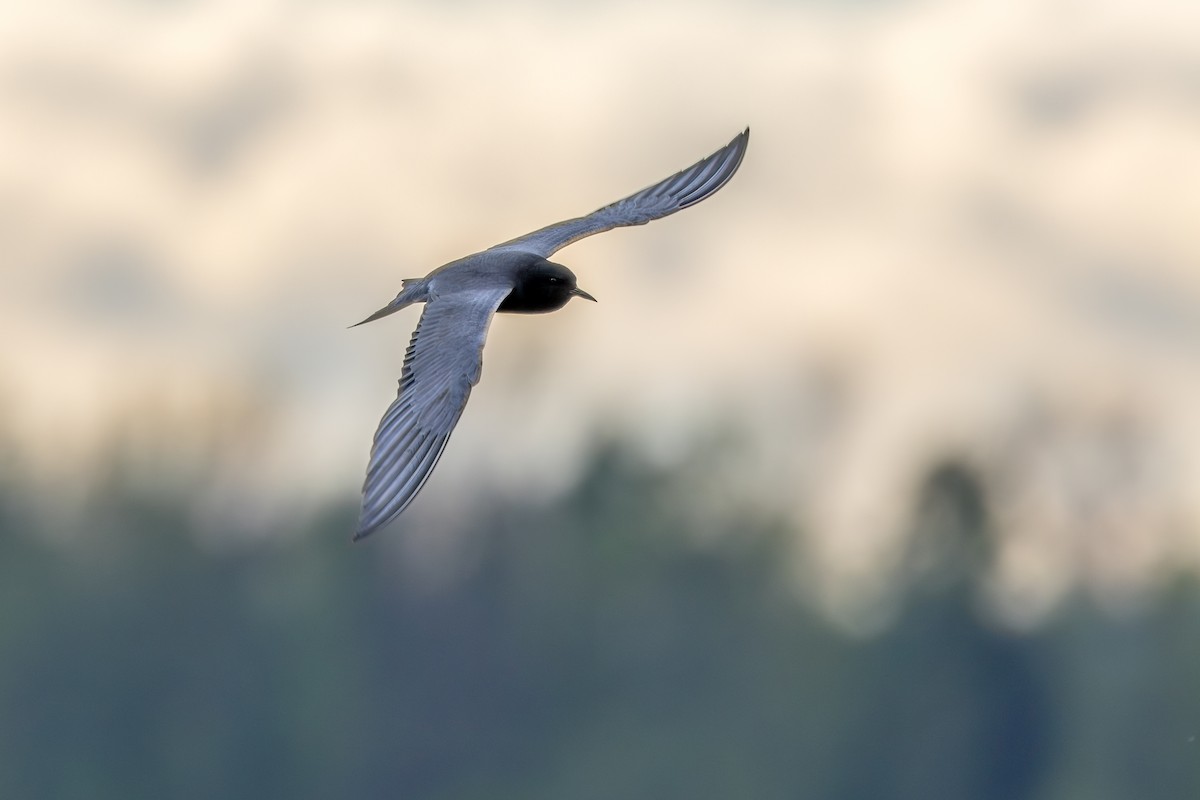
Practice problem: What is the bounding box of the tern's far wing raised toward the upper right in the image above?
[490,128,750,258]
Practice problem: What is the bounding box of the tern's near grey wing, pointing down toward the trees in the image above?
[354,287,511,540]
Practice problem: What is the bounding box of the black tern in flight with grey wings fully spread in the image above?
[352,128,750,540]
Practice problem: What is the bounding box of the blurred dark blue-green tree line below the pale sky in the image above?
[0,446,1200,800]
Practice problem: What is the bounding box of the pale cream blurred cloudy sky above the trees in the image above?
[0,0,1200,615]
